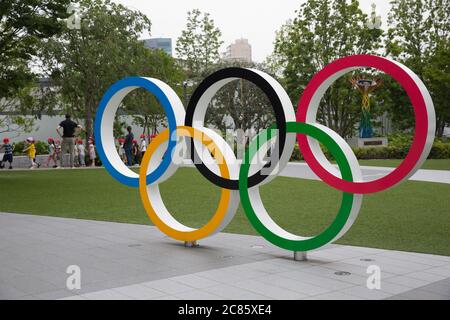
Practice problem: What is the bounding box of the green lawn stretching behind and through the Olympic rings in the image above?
[0,168,450,256]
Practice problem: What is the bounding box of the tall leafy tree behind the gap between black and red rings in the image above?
[272,0,383,137]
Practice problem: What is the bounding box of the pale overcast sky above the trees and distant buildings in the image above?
[114,0,390,62]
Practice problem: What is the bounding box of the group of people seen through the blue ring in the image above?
[118,126,155,166]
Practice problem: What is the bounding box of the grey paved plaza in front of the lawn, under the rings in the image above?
[0,213,450,300]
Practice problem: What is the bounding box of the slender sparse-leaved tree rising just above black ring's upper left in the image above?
[175,9,223,79]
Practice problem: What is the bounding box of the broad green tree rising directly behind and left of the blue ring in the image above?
[40,0,151,141]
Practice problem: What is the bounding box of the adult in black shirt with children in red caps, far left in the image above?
[0,114,96,169]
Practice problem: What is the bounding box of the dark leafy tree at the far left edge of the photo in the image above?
[0,0,69,134]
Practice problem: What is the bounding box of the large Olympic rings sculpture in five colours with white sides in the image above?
[94,55,436,252]
